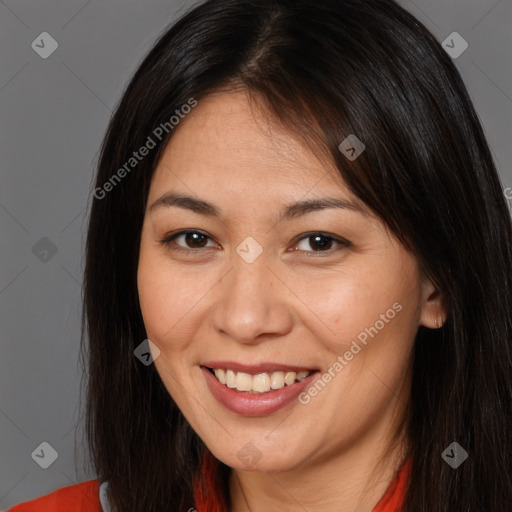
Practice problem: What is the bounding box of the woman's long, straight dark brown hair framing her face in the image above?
[77,0,512,512]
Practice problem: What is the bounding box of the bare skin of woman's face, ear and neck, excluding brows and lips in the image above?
[137,91,445,512]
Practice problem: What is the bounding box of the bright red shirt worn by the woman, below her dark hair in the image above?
[7,459,411,512]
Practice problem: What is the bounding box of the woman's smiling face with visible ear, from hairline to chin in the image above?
[138,92,442,471]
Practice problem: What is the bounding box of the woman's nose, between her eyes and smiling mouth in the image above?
[210,254,293,344]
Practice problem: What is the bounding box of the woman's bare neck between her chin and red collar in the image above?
[229,411,408,512]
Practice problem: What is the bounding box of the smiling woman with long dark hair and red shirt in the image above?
[12,0,512,512]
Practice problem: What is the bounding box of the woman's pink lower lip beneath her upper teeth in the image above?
[201,366,318,416]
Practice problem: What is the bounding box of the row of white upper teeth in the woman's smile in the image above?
[213,368,310,393]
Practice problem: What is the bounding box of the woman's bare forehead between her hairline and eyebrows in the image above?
[151,91,350,199]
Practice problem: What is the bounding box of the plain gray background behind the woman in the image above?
[0,0,512,510]
